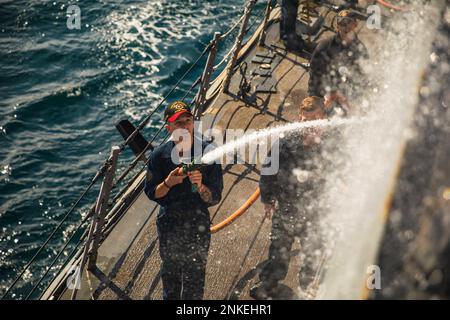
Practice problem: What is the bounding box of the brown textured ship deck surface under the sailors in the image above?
[56,1,381,300]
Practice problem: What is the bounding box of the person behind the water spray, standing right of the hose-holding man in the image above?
[250,97,330,299]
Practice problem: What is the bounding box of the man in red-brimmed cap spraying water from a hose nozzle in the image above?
[145,101,223,300]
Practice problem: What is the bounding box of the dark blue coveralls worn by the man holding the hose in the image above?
[145,138,223,300]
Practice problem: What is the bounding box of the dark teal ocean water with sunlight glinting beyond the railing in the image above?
[0,0,264,299]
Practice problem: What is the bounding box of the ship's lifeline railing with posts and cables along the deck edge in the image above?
[1,0,273,299]
